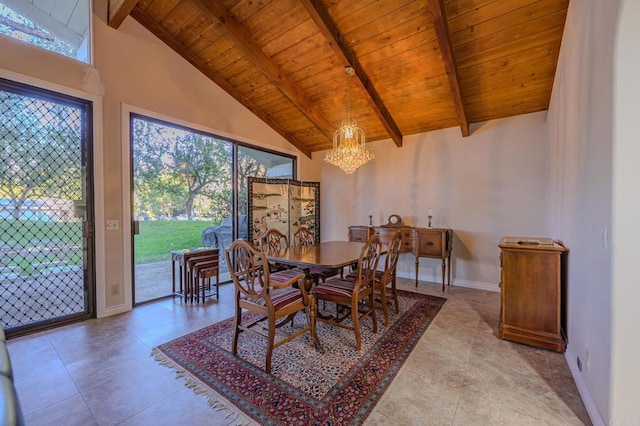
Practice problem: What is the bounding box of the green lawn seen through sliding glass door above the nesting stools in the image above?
[134,220,217,264]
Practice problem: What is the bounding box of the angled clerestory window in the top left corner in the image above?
[0,0,91,63]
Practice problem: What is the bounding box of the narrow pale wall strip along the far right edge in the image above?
[609,0,640,425]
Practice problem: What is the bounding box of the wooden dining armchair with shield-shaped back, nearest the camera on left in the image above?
[225,240,316,373]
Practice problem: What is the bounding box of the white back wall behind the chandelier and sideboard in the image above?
[314,112,547,290]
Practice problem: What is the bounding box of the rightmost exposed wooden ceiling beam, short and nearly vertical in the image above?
[428,0,469,137]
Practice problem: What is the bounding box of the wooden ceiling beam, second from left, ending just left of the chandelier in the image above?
[193,0,336,144]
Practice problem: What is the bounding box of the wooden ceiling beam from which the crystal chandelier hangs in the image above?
[300,0,402,147]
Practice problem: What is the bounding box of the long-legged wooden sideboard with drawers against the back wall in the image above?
[349,224,453,291]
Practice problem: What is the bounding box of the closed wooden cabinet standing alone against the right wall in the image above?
[498,237,566,352]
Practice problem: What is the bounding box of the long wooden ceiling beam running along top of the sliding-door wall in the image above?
[131,10,311,158]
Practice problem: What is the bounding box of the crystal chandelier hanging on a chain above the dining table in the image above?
[324,66,375,175]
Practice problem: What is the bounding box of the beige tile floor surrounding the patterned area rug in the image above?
[8,279,590,426]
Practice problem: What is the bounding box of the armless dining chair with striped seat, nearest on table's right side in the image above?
[312,235,382,351]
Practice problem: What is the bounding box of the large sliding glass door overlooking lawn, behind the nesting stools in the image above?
[130,114,295,304]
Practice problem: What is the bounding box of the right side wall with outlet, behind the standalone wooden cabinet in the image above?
[547,0,617,424]
